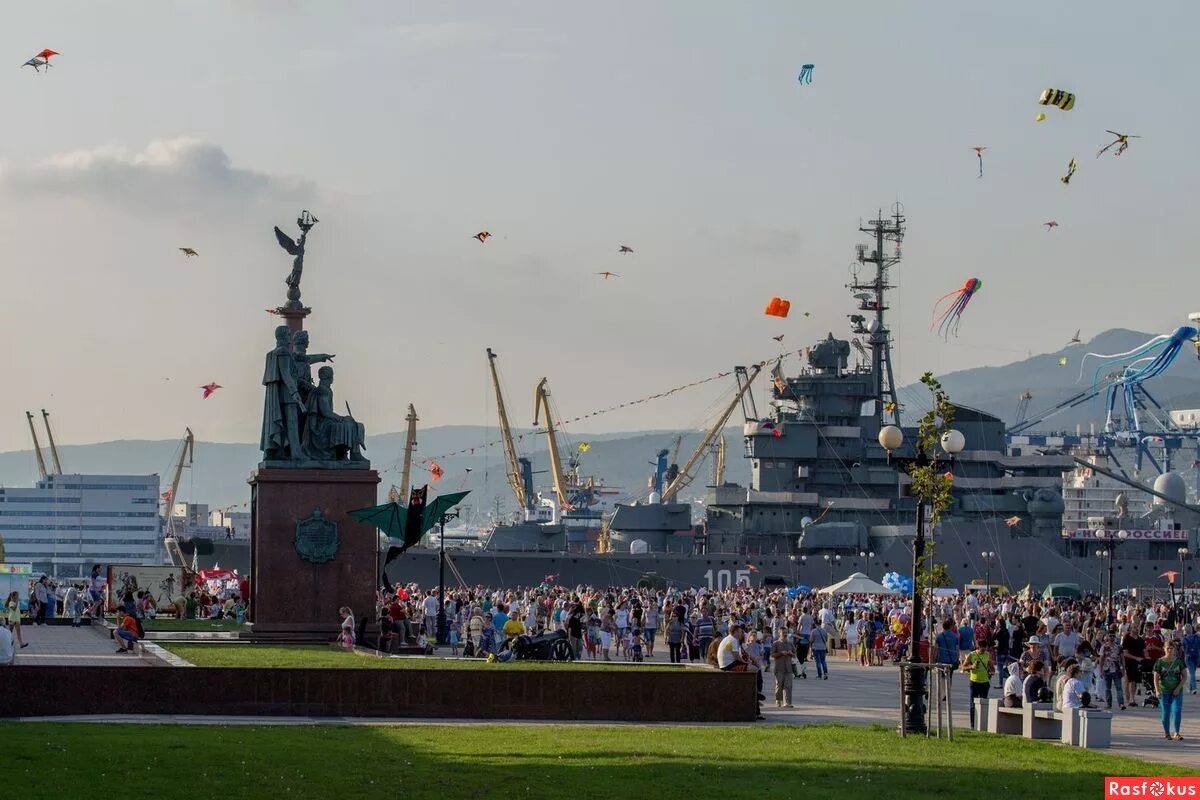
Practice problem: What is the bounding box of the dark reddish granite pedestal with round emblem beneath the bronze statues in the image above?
[250,467,379,642]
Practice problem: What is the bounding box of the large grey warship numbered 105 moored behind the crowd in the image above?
[388,204,1200,591]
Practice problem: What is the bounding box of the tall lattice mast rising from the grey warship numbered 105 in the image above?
[847,209,905,425]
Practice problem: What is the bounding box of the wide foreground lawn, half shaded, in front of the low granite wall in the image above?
[0,722,1195,800]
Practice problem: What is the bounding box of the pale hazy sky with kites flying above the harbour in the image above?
[0,0,1200,450]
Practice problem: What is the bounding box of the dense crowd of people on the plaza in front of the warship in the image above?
[364,584,1200,739]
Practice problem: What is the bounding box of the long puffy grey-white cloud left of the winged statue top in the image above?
[0,138,313,205]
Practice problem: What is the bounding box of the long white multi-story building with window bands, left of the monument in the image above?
[0,475,162,578]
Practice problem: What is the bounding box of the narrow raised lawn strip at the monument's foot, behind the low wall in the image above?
[160,642,684,672]
